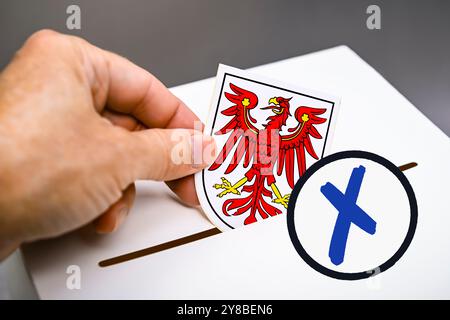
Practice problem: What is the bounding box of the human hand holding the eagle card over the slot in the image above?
[0,31,215,258]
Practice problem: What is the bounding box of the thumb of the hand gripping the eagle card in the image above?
[120,129,216,183]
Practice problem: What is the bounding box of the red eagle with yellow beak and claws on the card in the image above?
[209,83,327,224]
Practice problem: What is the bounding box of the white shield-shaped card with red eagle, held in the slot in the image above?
[195,65,339,231]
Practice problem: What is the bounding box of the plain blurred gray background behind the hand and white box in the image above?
[0,0,450,298]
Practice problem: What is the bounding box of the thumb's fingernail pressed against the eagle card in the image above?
[191,133,216,169]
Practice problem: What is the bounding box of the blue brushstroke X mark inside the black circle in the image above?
[320,166,377,266]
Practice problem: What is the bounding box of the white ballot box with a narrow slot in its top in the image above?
[23,46,450,299]
